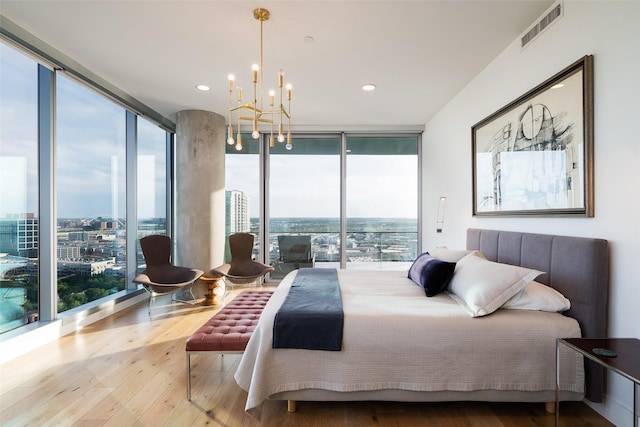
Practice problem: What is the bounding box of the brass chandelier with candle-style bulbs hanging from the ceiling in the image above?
[227,8,292,151]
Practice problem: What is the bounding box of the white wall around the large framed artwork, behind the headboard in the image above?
[423,0,640,426]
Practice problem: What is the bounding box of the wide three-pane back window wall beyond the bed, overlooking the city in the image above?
[226,133,420,279]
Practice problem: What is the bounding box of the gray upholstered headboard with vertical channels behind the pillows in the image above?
[467,228,609,402]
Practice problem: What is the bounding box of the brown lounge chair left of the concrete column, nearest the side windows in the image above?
[133,235,204,315]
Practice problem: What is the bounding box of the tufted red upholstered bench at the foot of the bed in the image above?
[185,291,273,400]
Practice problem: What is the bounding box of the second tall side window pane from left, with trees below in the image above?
[56,75,127,313]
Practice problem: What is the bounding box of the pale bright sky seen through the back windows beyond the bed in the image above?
[225,150,418,218]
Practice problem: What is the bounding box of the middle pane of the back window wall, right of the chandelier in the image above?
[267,135,341,279]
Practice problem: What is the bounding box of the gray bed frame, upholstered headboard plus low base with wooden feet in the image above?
[269,228,609,412]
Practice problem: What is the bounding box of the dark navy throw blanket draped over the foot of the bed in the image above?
[273,268,344,351]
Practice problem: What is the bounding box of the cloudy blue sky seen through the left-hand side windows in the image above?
[0,44,166,218]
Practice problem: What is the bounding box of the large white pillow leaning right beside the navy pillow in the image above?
[449,251,543,317]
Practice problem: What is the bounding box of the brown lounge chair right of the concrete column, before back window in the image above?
[208,233,273,299]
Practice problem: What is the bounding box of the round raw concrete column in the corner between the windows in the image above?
[175,110,226,288]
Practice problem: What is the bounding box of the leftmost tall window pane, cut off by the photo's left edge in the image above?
[0,43,39,333]
